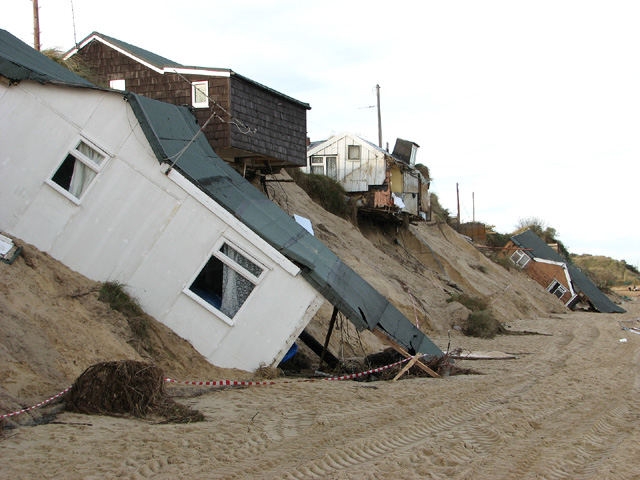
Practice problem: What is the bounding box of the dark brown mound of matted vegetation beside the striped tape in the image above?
[66,360,204,423]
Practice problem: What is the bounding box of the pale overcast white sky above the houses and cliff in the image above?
[5,0,640,265]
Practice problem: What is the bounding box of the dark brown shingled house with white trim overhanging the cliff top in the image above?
[66,32,310,171]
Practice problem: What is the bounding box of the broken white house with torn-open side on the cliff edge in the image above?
[302,133,429,215]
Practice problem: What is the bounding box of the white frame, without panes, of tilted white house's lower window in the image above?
[182,237,269,326]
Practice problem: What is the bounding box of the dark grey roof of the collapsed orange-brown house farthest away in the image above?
[511,230,626,313]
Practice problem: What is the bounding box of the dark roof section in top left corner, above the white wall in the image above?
[0,30,95,87]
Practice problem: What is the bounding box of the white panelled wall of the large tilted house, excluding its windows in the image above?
[0,82,322,370]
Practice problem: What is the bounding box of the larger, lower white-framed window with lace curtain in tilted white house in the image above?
[184,240,266,325]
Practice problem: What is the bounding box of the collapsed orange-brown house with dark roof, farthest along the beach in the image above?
[504,230,625,313]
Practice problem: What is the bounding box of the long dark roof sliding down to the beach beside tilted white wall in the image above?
[126,93,442,356]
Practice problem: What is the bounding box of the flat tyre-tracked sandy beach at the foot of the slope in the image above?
[0,298,640,479]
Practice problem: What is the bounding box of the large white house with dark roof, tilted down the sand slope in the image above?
[0,30,442,370]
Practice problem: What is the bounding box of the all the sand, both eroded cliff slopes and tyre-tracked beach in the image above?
[0,171,640,479]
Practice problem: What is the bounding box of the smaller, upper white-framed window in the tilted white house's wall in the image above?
[47,139,108,203]
